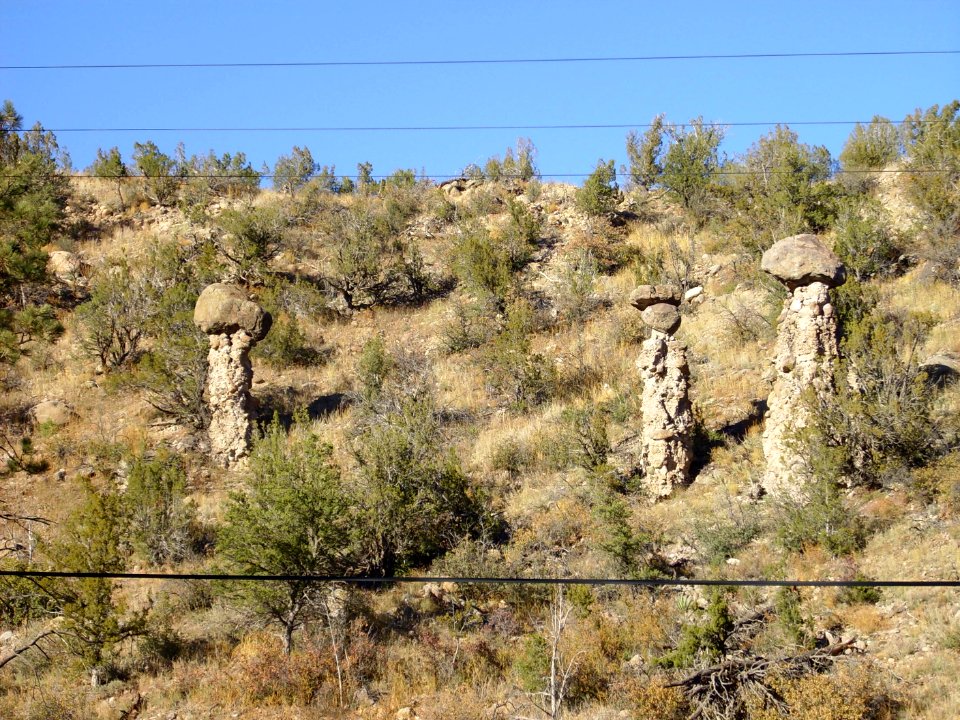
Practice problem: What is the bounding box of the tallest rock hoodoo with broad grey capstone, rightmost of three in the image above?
[760,235,846,496]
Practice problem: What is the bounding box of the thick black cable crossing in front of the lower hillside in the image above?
[0,570,960,588]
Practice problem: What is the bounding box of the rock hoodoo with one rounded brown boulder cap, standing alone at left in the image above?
[193,283,272,467]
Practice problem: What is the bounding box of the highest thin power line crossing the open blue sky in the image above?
[0,50,960,70]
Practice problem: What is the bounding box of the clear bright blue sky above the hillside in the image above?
[0,0,960,181]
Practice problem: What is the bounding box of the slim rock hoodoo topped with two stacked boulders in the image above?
[630,285,693,497]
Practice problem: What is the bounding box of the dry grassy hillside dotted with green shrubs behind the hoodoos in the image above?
[0,105,960,719]
